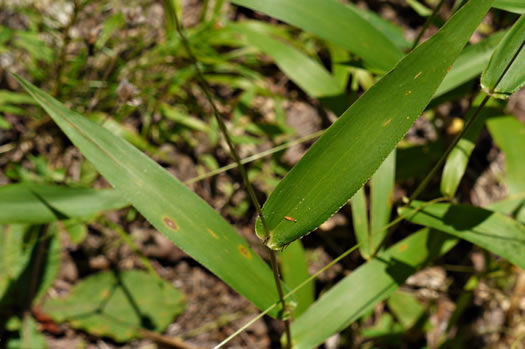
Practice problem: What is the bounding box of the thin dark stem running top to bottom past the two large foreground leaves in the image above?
[168,7,292,348]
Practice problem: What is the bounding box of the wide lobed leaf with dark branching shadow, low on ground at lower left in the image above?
[41,270,184,342]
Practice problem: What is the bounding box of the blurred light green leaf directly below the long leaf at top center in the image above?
[229,22,344,98]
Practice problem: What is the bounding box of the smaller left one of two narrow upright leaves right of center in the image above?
[351,186,372,259]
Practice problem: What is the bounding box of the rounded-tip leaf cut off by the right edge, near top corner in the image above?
[481,15,525,98]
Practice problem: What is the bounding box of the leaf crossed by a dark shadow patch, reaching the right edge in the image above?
[400,202,525,268]
